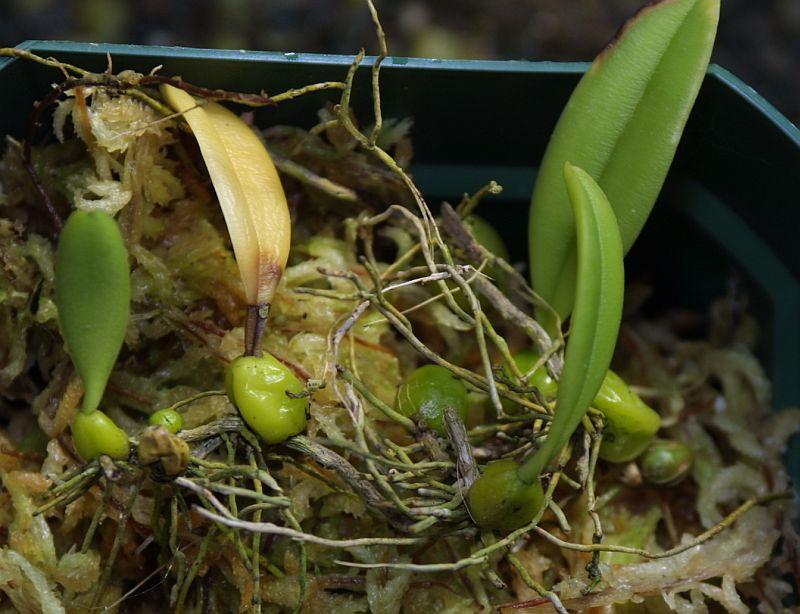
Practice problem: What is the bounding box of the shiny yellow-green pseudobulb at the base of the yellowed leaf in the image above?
[225,354,308,443]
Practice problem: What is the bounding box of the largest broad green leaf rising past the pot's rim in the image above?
[528,0,720,320]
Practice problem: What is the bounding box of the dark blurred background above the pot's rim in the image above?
[0,0,800,123]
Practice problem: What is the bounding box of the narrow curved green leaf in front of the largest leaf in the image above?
[519,163,625,484]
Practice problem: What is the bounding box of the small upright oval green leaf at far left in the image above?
[55,211,131,412]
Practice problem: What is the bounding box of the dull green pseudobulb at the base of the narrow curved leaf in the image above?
[467,459,544,531]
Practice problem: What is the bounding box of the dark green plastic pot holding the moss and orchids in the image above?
[0,41,800,478]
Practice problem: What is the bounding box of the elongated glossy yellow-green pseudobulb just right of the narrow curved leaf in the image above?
[592,371,661,463]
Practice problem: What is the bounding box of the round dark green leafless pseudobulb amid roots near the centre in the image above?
[396,365,469,437]
